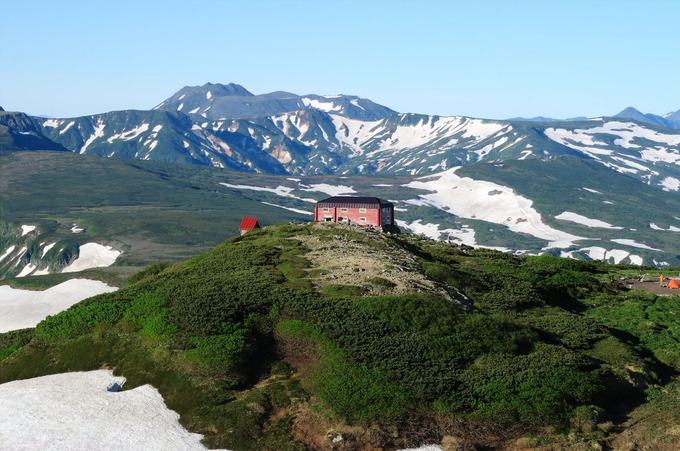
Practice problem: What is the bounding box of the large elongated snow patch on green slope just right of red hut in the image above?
[403,167,587,248]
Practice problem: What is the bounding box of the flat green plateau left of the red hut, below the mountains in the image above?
[0,152,305,274]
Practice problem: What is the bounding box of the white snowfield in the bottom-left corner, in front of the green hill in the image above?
[0,370,228,451]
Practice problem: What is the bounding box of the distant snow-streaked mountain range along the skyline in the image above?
[0,83,680,191]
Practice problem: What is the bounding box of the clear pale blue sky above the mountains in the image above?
[0,0,680,119]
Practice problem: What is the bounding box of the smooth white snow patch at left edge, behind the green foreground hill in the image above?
[0,279,118,333]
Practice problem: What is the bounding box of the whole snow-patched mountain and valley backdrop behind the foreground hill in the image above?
[0,83,680,277]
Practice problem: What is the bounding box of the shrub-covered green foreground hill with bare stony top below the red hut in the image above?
[0,224,680,450]
